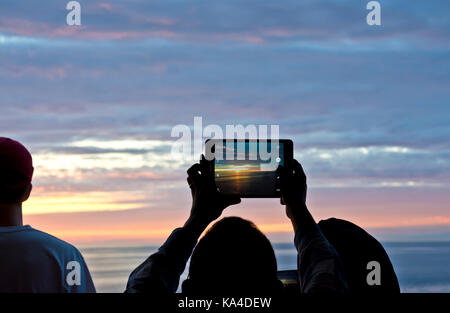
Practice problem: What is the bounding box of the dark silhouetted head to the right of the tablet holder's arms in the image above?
[319,218,400,294]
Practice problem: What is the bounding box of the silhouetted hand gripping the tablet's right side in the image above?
[277,159,307,223]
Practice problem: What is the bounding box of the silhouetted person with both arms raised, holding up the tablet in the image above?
[125,157,347,295]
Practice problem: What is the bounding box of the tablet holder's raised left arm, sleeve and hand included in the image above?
[125,158,240,294]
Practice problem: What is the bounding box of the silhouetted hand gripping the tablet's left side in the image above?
[185,155,241,231]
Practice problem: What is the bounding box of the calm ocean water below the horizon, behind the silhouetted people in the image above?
[80,242,450,292]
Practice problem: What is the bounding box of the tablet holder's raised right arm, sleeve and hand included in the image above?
[279,160,347,293]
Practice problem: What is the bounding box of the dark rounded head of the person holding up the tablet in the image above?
[183,217,281,294]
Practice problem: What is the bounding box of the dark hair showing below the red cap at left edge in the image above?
[0,170,29,204]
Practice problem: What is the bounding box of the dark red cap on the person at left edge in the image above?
[0,137,34,187]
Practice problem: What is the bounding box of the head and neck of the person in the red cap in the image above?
[0,137,34,226]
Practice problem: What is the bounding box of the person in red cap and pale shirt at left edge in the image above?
[0,137,95,293]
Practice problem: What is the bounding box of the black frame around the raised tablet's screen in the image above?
[205,139,294,198]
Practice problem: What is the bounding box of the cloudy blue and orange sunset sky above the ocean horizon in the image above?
[0,0,450,244]
